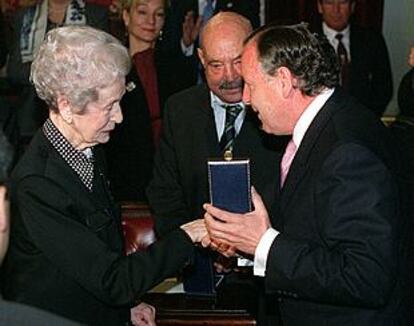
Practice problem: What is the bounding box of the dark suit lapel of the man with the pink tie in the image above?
[280,90,344,211]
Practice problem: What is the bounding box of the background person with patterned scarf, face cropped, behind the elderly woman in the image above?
[7,0,109,153]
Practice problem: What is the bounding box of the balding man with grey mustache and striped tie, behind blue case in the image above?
[147,12,278,290]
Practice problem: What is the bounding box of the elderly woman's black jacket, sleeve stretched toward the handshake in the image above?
[4,132,193,325]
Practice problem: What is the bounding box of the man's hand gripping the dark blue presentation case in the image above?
[203,188,270,255]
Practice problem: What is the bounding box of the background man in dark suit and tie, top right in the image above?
[318,0,392,116]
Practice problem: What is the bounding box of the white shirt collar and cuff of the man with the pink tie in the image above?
[253,89,334,276]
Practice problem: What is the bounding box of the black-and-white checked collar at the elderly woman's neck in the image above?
[43,119,94,191]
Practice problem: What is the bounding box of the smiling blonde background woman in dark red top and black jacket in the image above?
[106,0,195,201]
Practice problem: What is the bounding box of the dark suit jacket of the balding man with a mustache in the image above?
[147,85,279,235]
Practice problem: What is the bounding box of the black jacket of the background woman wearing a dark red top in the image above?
[105,47,195,201]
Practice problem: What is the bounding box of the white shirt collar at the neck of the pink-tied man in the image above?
[292,88,335,148]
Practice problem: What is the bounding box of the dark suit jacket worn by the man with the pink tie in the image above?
[265,90,404,326]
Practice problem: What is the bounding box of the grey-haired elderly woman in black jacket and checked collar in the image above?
[1,26,206,325]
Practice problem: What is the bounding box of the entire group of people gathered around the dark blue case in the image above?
[0,0,414,326]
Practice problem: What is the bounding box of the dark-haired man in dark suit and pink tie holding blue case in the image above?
[204,25,404,326]
